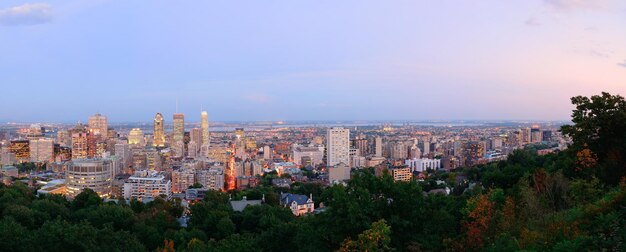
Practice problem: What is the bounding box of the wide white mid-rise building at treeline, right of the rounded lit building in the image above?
[124,170,172,201]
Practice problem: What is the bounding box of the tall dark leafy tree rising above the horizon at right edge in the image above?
[561,92,626,185]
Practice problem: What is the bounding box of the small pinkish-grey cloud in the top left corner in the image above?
[0,3,52,25]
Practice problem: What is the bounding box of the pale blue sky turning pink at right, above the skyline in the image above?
[0,0,626,122]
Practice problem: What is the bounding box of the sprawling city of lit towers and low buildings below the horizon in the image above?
[0,111,568,215]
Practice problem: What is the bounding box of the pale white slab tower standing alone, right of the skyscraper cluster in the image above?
[326,127,350,166]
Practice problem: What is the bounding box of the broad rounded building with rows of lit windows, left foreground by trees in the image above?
[65,159,114,198]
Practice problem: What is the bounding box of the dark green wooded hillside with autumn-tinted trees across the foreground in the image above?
[0,93,626,251]
